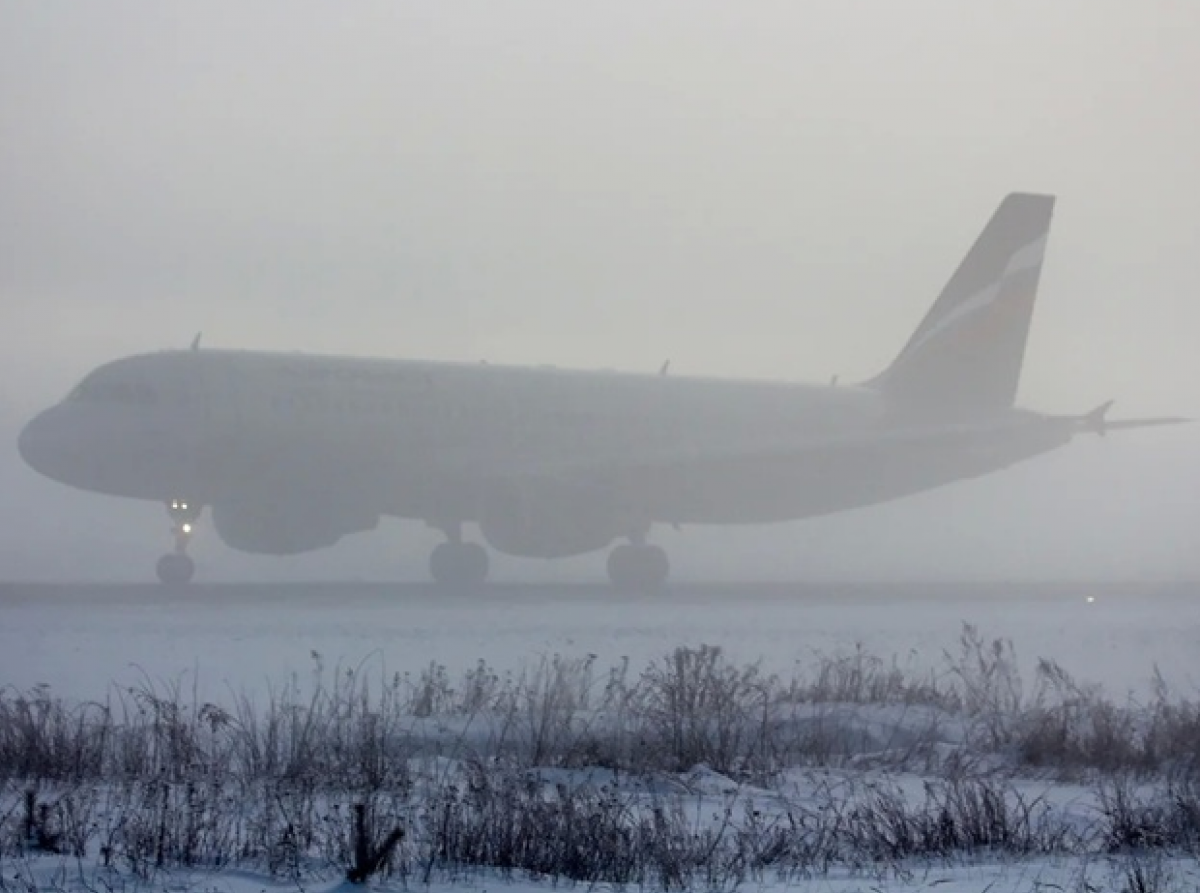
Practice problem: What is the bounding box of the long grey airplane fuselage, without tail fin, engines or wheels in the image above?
[23,350,1066,525]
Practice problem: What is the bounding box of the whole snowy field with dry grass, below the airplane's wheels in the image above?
[0,583,1200,893]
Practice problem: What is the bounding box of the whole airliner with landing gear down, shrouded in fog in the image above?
[18,193,1182,591]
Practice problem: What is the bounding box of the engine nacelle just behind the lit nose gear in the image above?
[212,498,379,555]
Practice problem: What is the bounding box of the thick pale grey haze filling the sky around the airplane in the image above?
[0,0,1200,579]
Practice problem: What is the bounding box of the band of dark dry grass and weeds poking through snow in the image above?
[0,627,1200,889]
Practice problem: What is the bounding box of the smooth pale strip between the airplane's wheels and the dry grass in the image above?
[0,582,1200,700]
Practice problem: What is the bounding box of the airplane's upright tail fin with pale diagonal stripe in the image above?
[868,192,1054,418]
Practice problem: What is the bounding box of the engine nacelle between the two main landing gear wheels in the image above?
[479,486,619,558]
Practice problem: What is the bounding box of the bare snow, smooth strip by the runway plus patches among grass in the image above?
[0,585,1200,893]
